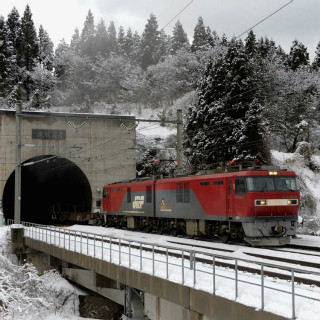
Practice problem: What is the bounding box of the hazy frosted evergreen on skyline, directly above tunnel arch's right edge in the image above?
[80,10,96,59]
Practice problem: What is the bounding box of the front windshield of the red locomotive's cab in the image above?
[246,176,298,192]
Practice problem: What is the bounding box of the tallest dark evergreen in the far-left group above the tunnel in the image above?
[17,5,39,101]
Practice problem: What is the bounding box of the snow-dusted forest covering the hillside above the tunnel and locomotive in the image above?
[0,6,320,172]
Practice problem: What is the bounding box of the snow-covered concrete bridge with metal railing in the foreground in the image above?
[12,224,320,320]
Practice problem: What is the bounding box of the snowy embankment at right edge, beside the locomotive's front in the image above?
[271,148,320,236]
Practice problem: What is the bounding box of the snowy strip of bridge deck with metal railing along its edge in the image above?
[8,220,320,319]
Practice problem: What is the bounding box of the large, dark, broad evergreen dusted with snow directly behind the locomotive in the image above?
[184,40,269,168]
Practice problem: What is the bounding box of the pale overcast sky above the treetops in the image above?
[0,0,320,59]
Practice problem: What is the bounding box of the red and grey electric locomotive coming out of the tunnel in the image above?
[102,167,300,246]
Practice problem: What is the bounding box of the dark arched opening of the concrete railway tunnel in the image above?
[2,155,92,224]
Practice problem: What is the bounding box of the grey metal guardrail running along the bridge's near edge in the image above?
[8,220,320,319]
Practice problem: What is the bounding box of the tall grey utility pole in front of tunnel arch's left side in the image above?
[14,101,22,224]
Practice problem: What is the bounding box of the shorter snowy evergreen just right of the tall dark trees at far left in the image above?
[38,25,54,71]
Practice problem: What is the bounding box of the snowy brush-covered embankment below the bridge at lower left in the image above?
[0,227,86,320]
